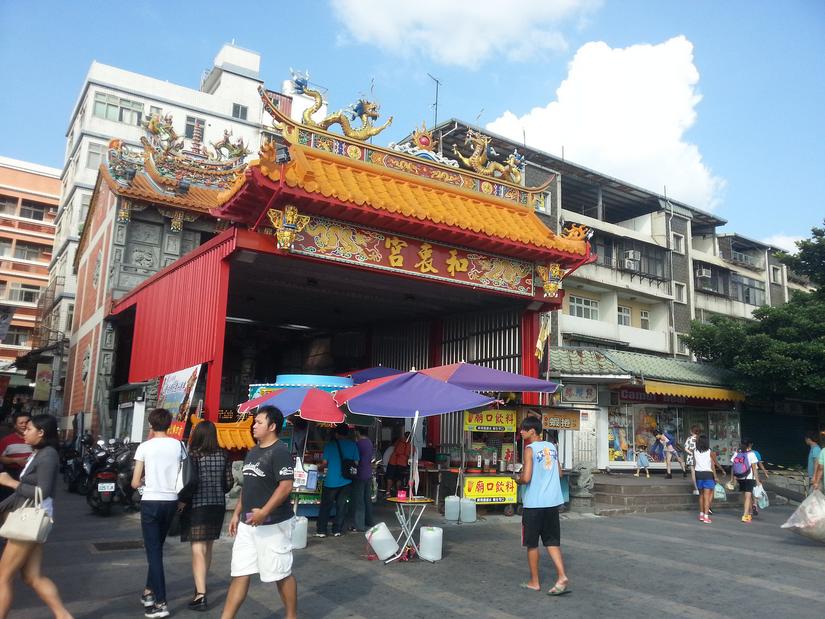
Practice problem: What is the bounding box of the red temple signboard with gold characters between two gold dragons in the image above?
[292,217,533,297]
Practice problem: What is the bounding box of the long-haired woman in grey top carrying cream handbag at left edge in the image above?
[0,415,72,619]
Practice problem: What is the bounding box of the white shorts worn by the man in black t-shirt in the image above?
[230,518,295,582]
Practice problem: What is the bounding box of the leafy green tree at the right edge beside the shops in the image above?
[686,220,825,400]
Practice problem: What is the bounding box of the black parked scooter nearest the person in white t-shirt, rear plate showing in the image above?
[86,438,140,516]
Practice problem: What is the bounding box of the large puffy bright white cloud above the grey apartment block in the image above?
[487,36,725,209]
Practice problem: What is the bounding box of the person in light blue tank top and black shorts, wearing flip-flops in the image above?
[516,417,570,595]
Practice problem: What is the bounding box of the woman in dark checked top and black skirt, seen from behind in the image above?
[180,421,232,611]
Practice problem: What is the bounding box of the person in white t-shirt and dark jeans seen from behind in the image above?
[132,408,186,617]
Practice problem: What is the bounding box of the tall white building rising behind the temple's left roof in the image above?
[40,45,272,412]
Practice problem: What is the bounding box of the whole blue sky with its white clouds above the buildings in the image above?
[0,0,825,249]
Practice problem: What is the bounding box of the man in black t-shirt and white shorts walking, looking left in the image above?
[221,406,298,619]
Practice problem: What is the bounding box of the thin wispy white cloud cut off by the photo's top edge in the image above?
[332,0,601,69]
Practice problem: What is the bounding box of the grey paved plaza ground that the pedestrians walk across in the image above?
[4,495,825,619]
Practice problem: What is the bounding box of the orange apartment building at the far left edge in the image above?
[0,157,60,414]
